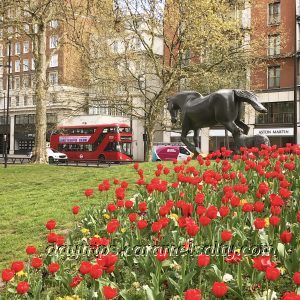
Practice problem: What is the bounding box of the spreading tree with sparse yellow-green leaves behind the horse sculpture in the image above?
[58,0,268,159]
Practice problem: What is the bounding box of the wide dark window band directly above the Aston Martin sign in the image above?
[255,101,294,124]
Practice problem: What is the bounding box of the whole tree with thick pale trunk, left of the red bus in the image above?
[1,0,89,163]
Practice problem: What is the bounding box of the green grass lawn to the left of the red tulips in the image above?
[0,163,156,270]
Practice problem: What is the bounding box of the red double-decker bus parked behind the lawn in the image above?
[50,123,132,162]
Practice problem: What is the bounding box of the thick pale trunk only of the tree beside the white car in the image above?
[33,24,47,164]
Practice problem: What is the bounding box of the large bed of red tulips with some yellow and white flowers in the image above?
[1,145,300,300]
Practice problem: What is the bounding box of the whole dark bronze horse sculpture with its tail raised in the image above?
[167,89,267,153]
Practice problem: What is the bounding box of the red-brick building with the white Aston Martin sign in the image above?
[248,0,300,146]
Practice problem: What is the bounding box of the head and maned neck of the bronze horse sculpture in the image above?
[167,91,202,124]
